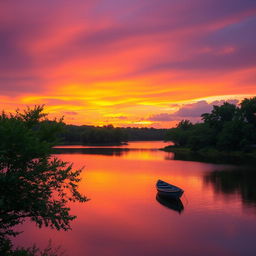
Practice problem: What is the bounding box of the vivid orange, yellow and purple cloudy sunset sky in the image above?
[0,0,256,128]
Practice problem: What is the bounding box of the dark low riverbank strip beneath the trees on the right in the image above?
[161,145,256,164]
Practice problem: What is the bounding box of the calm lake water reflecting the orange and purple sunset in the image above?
[15,142,256,256]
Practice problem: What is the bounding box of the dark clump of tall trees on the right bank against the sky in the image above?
[165,97,256,152]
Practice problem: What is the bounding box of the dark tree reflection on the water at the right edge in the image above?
[204,168,256,207]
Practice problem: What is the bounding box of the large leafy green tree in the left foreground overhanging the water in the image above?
[0,106,87,254]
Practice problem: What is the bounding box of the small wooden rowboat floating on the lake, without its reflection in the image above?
[156,180,184,199]
